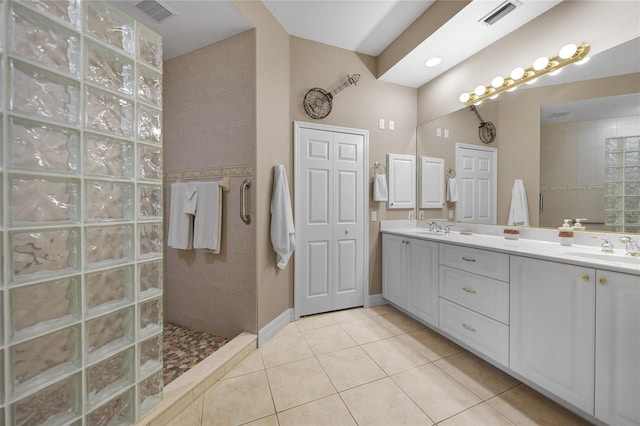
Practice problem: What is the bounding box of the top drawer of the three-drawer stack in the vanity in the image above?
[440,244,509,281]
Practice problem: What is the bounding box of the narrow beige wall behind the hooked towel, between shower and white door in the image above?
[234,1,293,330]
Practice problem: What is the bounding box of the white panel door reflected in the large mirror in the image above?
[456,143,498,225]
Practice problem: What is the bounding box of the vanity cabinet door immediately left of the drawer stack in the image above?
[407,239,438,327]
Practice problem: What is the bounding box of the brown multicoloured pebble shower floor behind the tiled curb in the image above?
[163,322,231,386]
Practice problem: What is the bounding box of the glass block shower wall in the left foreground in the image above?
[0,0,162,425]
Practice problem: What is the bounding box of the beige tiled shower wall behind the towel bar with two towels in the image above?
[163,31,256,337]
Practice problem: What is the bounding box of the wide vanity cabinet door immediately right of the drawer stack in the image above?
[509,256,596,415]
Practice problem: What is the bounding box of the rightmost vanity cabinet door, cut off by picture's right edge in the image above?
[595,271,640,425]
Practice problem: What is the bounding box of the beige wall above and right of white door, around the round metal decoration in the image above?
[290,37,416,294]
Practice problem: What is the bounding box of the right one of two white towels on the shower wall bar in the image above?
[193,182,222,254]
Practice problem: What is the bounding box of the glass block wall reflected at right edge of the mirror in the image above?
[605,136,640,233]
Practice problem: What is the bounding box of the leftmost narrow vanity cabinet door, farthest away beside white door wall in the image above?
[382,234,407,308]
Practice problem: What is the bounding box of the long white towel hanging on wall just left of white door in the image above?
[271,164,296,269]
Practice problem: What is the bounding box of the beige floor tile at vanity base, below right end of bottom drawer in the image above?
[435,352,520,401]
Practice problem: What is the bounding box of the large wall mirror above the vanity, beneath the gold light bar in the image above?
[416,38,640,232]
